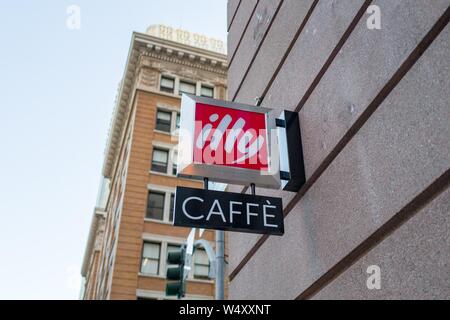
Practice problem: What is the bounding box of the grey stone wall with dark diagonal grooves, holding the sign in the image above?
[228,0,450,299]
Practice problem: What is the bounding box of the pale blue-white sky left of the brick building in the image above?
[0,0,226,299]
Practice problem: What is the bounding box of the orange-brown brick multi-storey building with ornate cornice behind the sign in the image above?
[81,26,227,299]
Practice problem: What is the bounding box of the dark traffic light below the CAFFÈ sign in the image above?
[166,246,186,299]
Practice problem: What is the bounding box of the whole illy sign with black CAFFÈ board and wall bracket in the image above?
[174,94,304,235]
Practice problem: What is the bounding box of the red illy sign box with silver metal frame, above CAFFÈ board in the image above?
[177,94,280,188]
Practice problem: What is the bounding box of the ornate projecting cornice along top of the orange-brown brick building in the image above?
[102,32,228,178]
